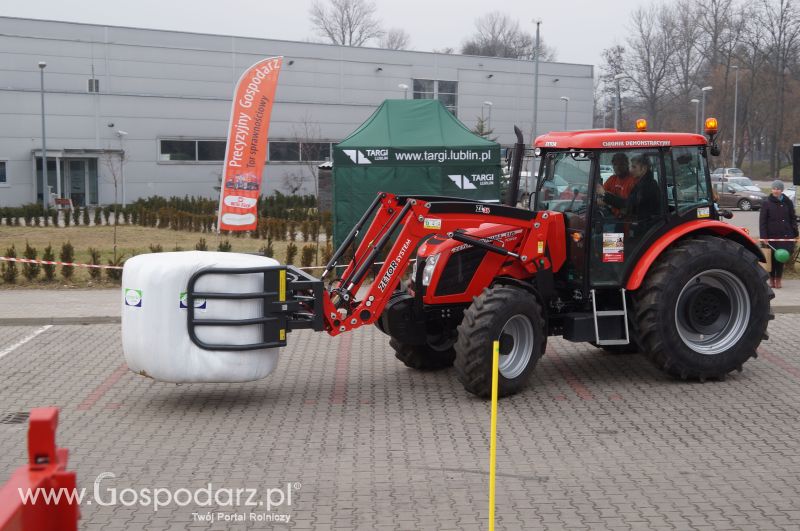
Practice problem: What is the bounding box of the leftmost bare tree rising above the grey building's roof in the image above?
[310,0,383,46]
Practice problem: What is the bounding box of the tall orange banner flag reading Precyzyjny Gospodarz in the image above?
[217,57,283,231]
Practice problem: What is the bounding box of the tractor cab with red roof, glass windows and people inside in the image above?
[531,121,719,298]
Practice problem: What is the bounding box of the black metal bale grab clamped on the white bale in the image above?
[186,265,324,351]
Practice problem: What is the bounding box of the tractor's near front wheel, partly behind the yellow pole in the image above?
[455,286,547,397]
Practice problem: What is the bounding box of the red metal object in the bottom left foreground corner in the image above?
[0,407,80,531]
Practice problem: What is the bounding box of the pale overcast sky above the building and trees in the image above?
[0,0,665,65]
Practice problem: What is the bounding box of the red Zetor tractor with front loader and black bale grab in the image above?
[188,120,773,396]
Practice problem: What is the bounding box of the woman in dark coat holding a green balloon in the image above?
[759,181,798,288]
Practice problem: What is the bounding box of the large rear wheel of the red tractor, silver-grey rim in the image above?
[635,236,774,380]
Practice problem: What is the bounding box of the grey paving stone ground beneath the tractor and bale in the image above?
[0,314,800,530]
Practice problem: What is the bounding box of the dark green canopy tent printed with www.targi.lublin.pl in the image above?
[333,100,501,245]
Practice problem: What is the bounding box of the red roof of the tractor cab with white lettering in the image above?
[533,129,708,149]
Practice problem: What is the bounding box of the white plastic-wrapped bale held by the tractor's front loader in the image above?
[122,251,278,383]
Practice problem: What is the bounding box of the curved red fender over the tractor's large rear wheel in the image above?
[625,220,766,291]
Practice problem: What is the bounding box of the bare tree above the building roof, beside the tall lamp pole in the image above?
[461,11,555,61]
